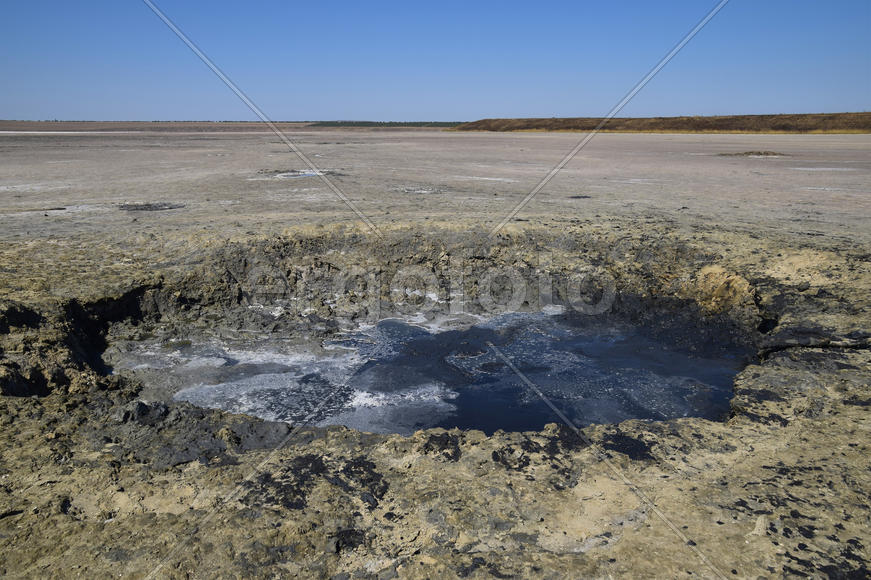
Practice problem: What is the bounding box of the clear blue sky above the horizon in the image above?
[0,0,871,120]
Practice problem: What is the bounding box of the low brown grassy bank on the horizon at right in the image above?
[454,113,871,133]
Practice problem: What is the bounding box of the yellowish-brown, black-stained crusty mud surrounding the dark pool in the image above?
[0,221,871,578]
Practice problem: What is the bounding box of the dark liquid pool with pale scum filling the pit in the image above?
[107,313,745,434]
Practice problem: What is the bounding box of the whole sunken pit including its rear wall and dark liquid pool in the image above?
[97,232,762,434]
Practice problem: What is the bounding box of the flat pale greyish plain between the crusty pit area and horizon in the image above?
[0,130,871,242]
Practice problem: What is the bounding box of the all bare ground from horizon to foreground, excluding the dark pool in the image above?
[0,131,871,578]
